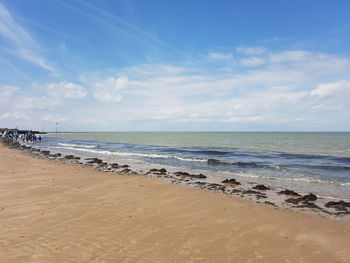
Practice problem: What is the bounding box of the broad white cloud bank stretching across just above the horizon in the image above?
[0,47,350,130]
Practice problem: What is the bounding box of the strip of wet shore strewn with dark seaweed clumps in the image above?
[4,142,350,221]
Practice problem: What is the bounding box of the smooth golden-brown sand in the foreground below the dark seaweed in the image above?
[0,146,350,262]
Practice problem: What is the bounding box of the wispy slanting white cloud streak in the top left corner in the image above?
[0,3,55,72]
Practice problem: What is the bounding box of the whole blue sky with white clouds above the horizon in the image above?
[0,0,350,131]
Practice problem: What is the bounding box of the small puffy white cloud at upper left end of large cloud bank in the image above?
[94,77,128,102]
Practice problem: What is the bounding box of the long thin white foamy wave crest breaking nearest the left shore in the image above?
[51,146,207,162]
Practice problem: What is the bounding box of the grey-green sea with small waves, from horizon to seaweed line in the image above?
[37,132,350,200]
